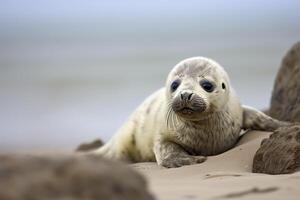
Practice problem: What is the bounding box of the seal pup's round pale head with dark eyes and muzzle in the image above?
[166,57,230,121]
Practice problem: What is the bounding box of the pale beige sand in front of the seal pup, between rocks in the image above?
[132,131,300,200]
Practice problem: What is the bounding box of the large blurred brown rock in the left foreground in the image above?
[0,155,153,200]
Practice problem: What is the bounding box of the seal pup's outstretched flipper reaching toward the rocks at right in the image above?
[242,106,292,131]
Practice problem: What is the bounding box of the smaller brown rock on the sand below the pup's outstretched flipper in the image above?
[253,126,300,174]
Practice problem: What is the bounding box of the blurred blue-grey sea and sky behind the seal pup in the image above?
[0,0,300,152]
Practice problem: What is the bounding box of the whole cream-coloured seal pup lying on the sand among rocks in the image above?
[93,57,288,168]
